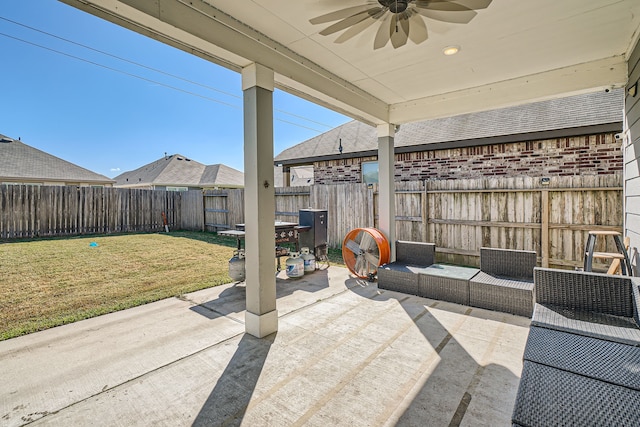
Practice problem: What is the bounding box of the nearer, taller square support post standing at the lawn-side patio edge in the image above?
[242,63,278,338]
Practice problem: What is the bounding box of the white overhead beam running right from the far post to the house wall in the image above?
[389,56,628,124]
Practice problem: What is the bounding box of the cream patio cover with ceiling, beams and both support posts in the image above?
[61,0,640,337]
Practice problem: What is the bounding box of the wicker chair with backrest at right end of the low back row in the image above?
[469,248,537,317]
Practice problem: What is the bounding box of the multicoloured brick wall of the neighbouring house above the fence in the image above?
[314,133,623,184]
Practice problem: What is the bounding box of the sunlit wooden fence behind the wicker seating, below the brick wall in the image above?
[199,175,623,267]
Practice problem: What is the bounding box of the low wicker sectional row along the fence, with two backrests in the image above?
[378,241,536,317]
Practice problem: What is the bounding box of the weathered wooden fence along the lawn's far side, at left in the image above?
[0,185,184,239]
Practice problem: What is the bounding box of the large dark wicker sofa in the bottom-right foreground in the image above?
[512,268,640,426]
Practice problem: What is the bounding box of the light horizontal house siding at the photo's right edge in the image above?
[624,38,640,276]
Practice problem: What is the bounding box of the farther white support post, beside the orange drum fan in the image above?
[378,123,396,261]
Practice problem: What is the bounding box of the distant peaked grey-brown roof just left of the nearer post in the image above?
[114,154,244,188]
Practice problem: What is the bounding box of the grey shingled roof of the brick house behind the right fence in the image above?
[275,89,624,164]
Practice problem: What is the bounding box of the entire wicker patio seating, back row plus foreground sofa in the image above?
[378,241,640,427]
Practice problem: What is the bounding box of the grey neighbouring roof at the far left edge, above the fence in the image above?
[0,135,114,184]
